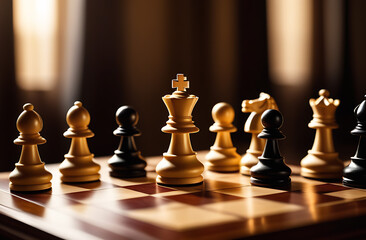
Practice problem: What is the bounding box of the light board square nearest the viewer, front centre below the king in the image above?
[127,203,239,231]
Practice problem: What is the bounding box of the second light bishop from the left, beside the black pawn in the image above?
[59,101,100,183]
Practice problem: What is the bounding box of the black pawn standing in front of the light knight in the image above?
[250,109,291,188]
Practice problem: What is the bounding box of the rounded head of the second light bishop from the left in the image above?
[66,101,90,129]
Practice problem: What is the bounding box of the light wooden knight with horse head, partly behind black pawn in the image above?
[240,93,278,176]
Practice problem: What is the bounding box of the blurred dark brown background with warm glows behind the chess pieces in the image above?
[0,0,366,171]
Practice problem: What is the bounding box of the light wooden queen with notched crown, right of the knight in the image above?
[300,89,344,180]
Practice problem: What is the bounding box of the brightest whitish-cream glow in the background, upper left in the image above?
[13,0,58,90]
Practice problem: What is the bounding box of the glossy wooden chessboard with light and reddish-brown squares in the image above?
[0,152,366,239]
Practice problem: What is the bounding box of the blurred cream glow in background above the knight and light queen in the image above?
[267,0,312,85]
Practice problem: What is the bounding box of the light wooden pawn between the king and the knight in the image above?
[206,102,241,172]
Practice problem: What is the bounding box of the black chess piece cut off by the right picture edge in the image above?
[343,95,366,188]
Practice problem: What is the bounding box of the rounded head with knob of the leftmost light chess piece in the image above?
[17,103,43,134]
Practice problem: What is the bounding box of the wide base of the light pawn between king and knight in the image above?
[206,147,240,172]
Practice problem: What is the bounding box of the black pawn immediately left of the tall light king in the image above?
[108,106,146,178]
